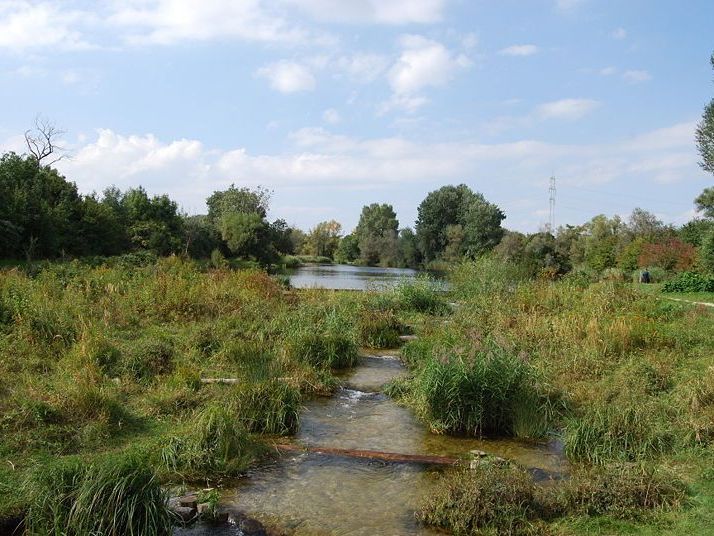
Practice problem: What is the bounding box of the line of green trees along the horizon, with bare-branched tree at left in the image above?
[5,51,714,276]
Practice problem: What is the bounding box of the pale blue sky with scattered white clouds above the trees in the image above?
[0,0,714,232]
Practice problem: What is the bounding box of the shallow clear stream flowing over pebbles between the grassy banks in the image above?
[180,355,565,536]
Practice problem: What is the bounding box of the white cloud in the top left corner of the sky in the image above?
[0,0,94,52]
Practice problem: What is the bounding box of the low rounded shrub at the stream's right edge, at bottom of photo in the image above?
[417,463,545,536]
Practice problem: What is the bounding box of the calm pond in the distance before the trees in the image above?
[288,264,419,290]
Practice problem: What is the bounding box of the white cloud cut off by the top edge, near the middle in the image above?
[283,0,446,25]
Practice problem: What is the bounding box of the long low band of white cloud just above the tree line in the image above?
[58,121,703,224]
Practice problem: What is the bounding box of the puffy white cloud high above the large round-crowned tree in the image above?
[387,35,471,95]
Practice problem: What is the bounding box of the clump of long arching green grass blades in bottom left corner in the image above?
[25,455,171,536]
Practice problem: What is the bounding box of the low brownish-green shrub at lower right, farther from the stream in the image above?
[561,464,687,519]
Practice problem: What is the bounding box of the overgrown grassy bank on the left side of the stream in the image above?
[0,258,418,534]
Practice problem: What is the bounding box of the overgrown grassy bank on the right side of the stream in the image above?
[390,260,714,534]
